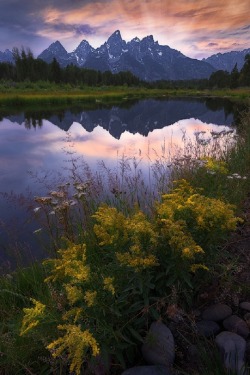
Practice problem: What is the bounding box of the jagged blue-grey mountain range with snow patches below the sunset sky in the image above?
[0,30,250,81]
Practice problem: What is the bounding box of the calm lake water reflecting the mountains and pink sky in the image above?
[0,99,239,268]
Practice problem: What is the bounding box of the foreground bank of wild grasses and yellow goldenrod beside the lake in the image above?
[0,111,250,375]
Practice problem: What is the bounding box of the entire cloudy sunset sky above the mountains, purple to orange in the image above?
[0,0,250,59]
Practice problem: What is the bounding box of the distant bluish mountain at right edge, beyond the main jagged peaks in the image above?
[202,48,250,72]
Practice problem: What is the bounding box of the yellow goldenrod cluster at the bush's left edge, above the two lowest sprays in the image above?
[44,243,90,283]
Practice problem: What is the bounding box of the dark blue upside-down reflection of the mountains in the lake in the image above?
[2,98,234,139]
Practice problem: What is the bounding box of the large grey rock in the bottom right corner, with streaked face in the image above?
[215,331,247,375]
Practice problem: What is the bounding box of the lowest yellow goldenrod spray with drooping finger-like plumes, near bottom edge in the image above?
[47,324,100,375]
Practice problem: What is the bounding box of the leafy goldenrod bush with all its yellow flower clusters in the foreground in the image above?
[21,180,240,374]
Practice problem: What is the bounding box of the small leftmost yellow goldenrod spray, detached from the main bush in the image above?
[20,298,46,336]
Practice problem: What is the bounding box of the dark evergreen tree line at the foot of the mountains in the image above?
[0,48,250,89]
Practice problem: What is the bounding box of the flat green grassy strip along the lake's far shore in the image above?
[0,82,250,106]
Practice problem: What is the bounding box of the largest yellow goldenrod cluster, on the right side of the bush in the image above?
[157,180,241,268]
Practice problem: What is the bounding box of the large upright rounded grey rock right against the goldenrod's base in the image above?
[142,322,175,367]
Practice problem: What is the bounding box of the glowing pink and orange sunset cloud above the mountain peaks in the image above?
[36,0,250,56]
